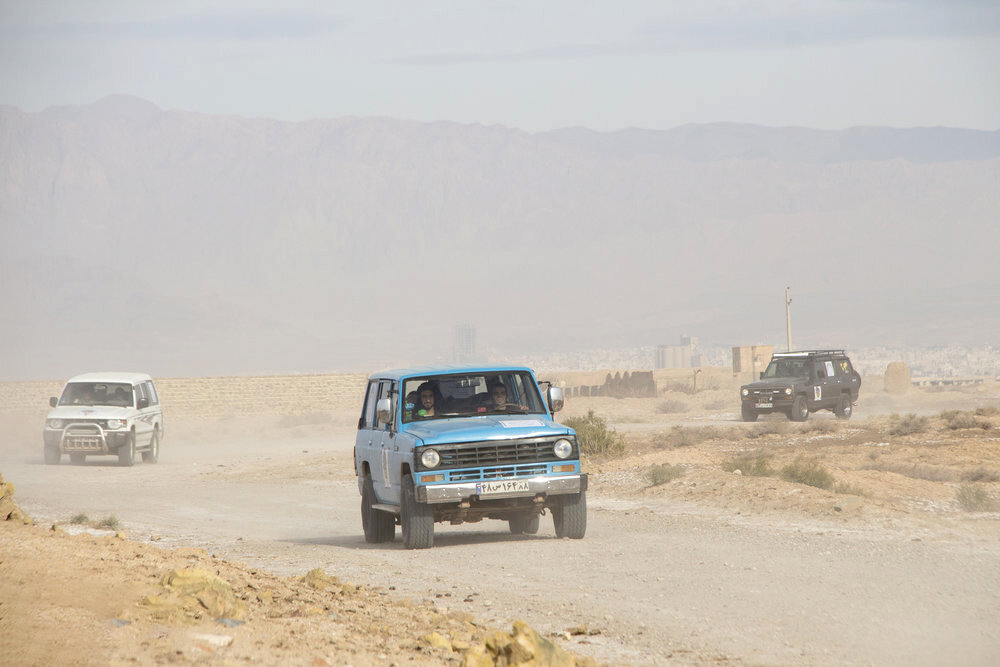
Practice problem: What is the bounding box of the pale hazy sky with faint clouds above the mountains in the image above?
[0,0,1000,131]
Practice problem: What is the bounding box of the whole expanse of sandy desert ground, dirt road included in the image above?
[0,385,1000,665]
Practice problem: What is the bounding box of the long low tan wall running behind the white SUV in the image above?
[0,373,367,419]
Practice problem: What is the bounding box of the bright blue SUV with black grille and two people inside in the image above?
[354,366,587,549]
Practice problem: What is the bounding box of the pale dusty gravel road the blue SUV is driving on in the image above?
[0,408,1000,665]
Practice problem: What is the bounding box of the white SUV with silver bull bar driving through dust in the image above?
[43,373,163,466]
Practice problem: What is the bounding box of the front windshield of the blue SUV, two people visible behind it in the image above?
[403,371,545,424]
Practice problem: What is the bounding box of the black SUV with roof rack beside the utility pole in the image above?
[740,350,861,422]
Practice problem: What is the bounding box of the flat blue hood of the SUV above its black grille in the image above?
[403,415,573,445]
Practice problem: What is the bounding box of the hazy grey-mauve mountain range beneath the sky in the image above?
[0,97,1000,375]
